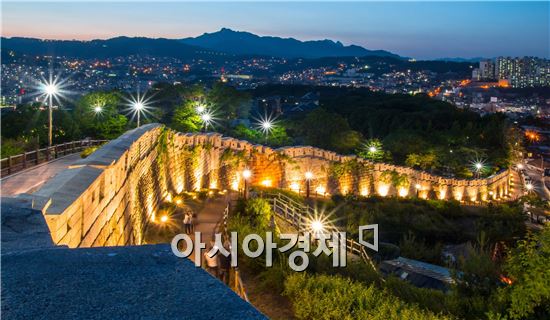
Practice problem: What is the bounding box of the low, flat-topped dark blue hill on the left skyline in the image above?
[2,37,223,59]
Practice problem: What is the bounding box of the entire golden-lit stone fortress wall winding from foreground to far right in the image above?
[32,124,510,247]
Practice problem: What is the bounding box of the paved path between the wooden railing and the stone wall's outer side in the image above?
[0,153,81,197]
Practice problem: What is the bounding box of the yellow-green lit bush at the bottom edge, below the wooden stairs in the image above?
[284,274,451,320]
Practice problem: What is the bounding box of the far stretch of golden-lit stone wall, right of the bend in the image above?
[172,133,511,201]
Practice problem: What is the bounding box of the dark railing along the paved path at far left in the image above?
[0,140,107,178]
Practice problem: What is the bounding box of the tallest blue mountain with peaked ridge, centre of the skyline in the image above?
[181,28,400,58]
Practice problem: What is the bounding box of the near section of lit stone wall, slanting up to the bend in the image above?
[33,124,167,247]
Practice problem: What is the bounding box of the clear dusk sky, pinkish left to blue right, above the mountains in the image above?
[2,1,550,59]
